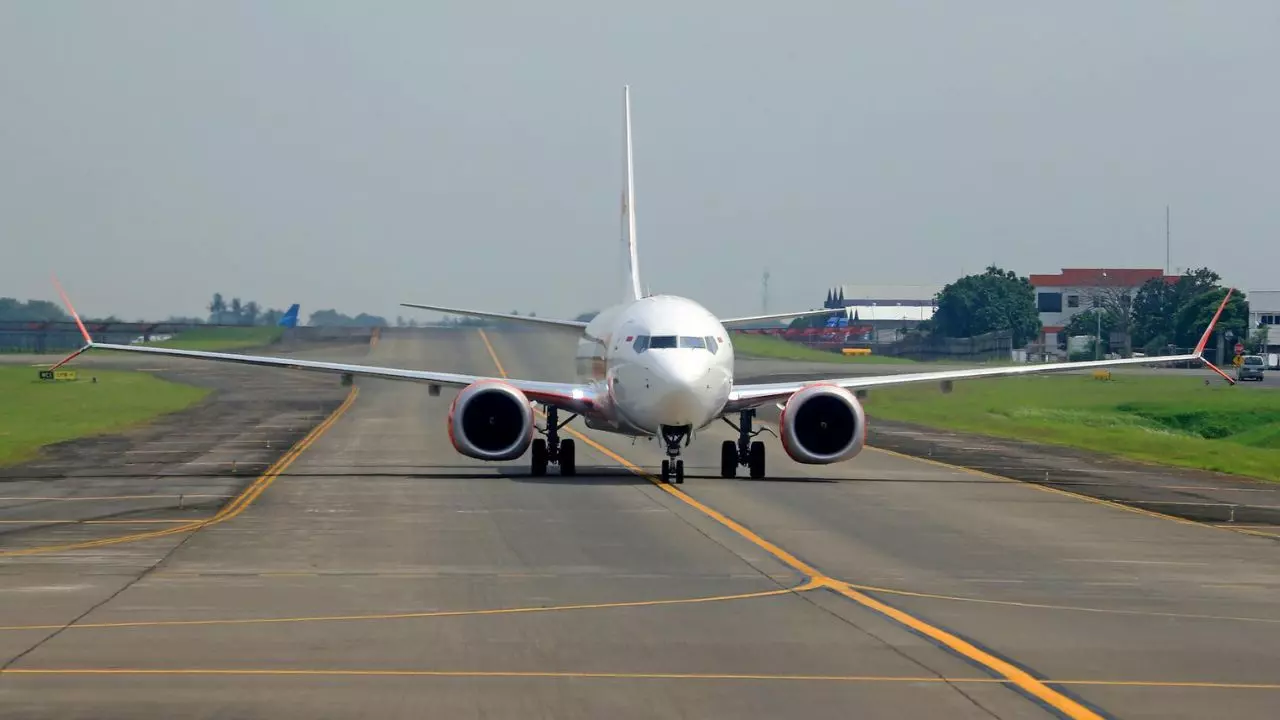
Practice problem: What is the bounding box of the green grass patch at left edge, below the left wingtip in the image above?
[0,366,209,465]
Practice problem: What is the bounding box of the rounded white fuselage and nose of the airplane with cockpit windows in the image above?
[577,295,733,434]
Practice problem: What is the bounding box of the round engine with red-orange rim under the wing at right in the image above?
[778,384,867,465]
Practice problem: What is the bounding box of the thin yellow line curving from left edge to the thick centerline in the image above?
[0,573,820,632]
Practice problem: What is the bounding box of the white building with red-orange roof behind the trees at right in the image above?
[1028,268,1178,347]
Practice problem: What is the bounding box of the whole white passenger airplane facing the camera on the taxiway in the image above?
[55,87,1233,484]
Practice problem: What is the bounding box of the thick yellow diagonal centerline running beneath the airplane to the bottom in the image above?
[479,329,1102,720]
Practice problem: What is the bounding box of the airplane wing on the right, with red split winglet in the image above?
[724,290,1235,413]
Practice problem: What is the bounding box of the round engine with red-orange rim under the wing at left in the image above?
[449,380,534,460]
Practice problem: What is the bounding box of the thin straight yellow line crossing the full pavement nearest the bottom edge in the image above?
[0,667,1280,691]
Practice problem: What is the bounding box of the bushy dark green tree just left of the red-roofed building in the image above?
[932,265,1041,347]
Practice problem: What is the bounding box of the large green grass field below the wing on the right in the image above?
[867,374,1280,480]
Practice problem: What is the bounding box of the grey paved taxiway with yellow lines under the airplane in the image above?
[0,331,1280,719]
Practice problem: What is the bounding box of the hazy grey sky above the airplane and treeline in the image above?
[0,0,1280,319]
